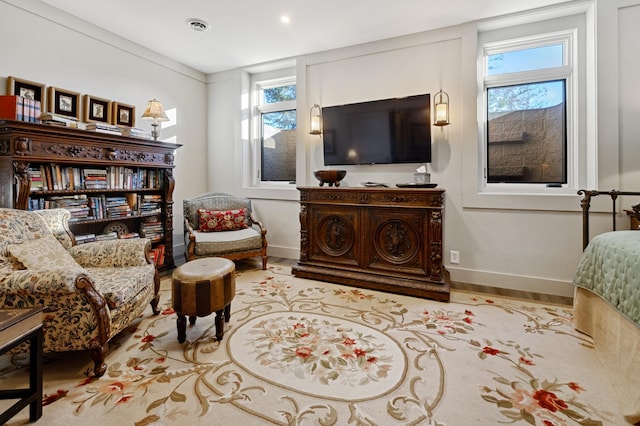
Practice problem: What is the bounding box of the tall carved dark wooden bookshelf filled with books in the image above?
[0,120,182,269]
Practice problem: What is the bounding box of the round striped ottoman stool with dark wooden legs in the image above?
[171,257,236,343]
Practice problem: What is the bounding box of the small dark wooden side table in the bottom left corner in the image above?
[0,308,44,424]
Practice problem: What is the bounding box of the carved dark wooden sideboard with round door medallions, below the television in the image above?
[292,187,449,301]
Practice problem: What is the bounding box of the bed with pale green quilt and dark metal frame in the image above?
[573,190,640,424]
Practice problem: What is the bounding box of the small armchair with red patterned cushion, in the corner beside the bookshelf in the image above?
[182,192,267,269]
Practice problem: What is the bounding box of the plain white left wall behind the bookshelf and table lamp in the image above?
[0,0,207,260]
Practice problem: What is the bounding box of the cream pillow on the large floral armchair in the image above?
[7,235,80,269]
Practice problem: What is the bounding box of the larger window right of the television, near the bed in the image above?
[483,33,575,187]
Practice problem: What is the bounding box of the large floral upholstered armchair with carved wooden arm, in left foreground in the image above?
[0,208,160,377]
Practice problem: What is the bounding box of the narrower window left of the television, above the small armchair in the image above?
[254,78,296,185]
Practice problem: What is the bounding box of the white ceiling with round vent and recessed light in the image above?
[42,0,566,74]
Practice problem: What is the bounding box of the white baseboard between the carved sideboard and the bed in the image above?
[447,266,574,297]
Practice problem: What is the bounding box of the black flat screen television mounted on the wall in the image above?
[322,93,431,166]
